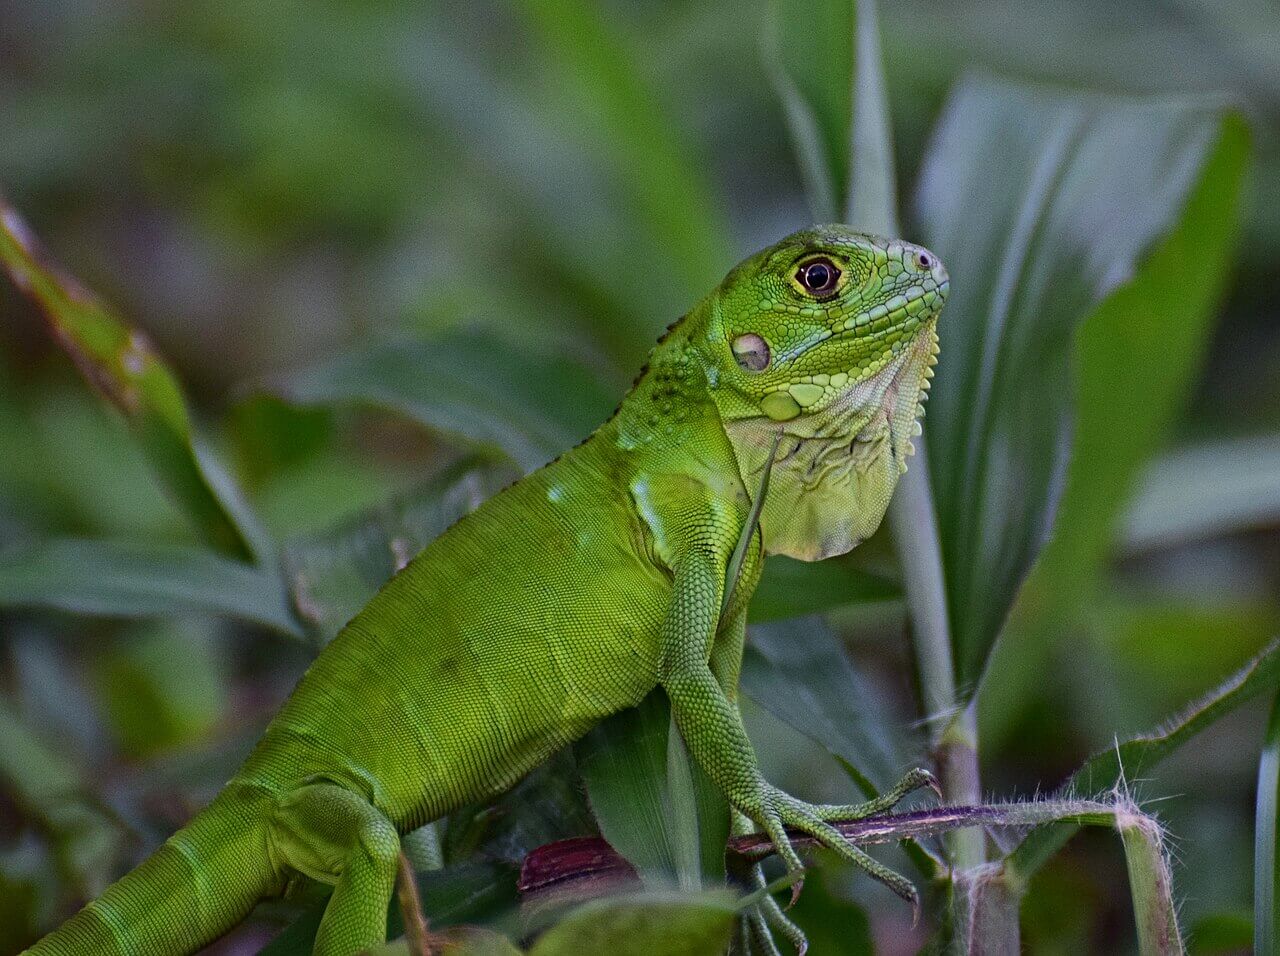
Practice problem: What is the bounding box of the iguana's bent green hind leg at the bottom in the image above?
[273,783,399,956]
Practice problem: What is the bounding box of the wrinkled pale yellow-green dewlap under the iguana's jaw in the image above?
[724,316,938,561]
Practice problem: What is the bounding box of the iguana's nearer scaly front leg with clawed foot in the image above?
[659,550,918,906]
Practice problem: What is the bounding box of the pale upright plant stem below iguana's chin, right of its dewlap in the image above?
[888,445,986,869]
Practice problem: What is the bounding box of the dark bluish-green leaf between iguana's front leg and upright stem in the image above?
[741,618,916,797]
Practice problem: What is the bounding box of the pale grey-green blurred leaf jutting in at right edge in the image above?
[1124,435,1280,552]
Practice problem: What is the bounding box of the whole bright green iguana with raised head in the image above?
[29,225,947,956]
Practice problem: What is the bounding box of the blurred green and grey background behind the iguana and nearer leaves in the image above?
[0,0,1280,953]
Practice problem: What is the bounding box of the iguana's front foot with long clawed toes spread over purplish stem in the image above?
[758,769,938,914]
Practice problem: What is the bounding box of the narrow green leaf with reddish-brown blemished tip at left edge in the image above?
[0,201,269,558]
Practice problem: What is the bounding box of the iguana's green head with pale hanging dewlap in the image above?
[703,225,947,561]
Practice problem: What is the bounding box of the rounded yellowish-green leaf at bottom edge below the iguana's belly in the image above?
[530,891,736,956]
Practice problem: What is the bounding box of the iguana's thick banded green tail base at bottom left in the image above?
[27,791,278,956]
